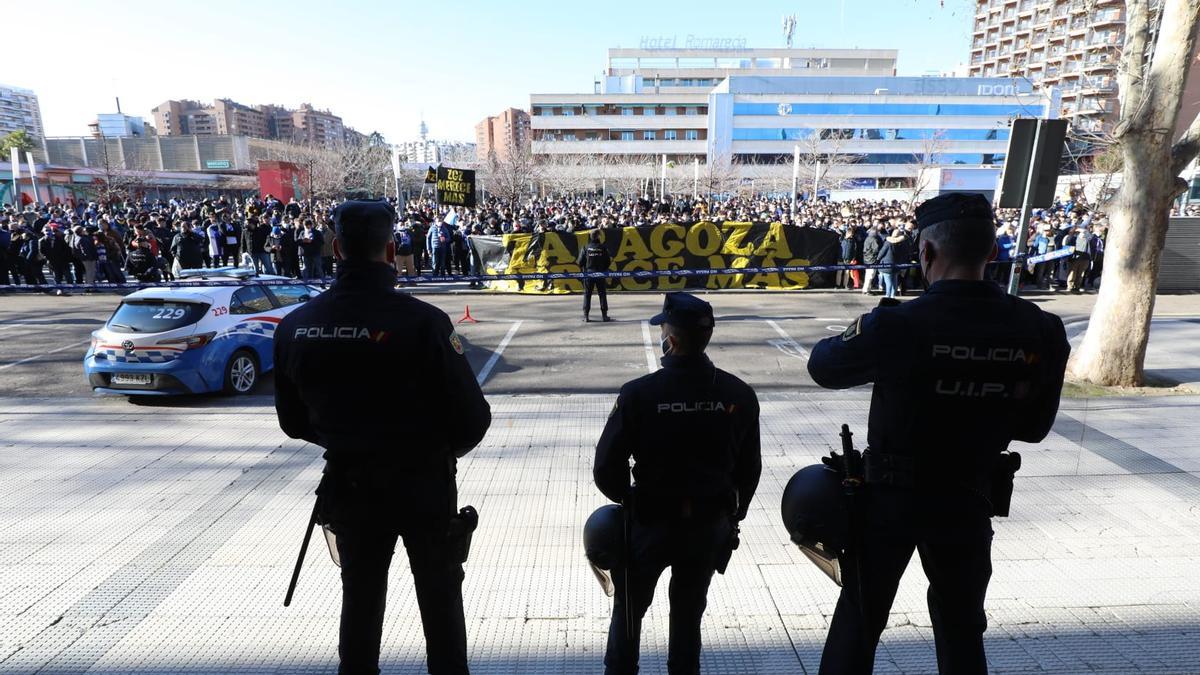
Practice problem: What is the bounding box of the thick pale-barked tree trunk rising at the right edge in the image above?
[1070,0,1200,386]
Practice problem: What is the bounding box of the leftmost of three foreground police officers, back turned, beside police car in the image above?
[275,201,491,675]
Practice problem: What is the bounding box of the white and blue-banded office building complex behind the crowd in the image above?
[530,49,1060,197]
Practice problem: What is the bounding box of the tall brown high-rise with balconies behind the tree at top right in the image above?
[968,0,1126,133]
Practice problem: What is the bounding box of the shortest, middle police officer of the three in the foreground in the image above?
[594,293,762,675]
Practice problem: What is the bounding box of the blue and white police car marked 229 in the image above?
[83,268,320,395]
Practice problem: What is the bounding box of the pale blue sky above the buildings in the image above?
[11,0,974,141]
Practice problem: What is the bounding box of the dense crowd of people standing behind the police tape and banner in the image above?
[0,190,1200,295]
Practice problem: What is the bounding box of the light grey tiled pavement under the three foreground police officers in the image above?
[0,393,1200,674]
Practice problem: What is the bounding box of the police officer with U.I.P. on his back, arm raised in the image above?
[809,195,1070,674]
